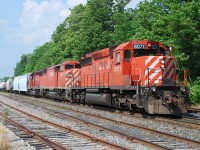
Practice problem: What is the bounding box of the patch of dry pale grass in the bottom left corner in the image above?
[0,124,11,150]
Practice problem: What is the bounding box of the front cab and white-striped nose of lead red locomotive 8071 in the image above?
[113,40,189,114]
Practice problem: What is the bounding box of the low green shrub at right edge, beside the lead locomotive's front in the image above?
[189,77,200,105]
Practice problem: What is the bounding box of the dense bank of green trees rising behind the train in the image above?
[15,0,200,103]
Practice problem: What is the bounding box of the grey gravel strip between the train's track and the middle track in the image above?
[33,95,200,141]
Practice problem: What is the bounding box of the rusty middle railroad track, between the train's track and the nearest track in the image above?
[0,93,200,149]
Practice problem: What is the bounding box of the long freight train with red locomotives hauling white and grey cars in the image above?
[3,40,189,115]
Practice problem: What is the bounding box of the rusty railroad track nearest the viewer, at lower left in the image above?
[0,99,127,150]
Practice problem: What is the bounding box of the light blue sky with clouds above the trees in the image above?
[0,0,141,78]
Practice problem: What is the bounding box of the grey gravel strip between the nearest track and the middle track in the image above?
[0,97,150,150]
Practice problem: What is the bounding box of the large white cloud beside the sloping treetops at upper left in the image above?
[17,0,86,44]
